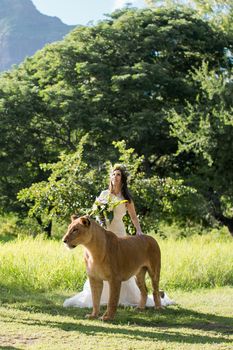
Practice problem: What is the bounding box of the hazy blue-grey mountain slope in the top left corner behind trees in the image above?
[0,0,74,71]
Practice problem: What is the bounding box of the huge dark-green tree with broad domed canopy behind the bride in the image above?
[0,8,232,226]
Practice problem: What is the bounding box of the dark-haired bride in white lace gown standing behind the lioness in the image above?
[63,164,174,308]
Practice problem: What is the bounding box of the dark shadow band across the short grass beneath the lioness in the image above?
[0,286,233,344]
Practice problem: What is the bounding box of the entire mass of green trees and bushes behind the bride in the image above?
[0,0,233,236]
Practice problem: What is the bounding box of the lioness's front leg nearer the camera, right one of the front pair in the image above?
[101,281,121,321]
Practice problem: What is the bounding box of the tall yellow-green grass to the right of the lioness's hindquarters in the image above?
[160,236,233,290]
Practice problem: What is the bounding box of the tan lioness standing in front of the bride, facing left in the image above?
[63,216,161,320]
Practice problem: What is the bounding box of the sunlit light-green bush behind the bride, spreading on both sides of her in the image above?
[18,135,205,237]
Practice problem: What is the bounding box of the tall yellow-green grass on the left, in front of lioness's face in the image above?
[0,236,86,291]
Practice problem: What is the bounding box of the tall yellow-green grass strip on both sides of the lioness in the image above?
[0,235,233,291]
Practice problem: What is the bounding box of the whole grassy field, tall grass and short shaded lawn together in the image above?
[0,232,233,350]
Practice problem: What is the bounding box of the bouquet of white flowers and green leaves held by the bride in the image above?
[90,195,127,227]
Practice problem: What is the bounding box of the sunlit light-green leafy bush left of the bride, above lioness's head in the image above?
[18,135,102,237]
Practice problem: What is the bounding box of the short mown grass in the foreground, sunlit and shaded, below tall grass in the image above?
[0,286,233,350]
